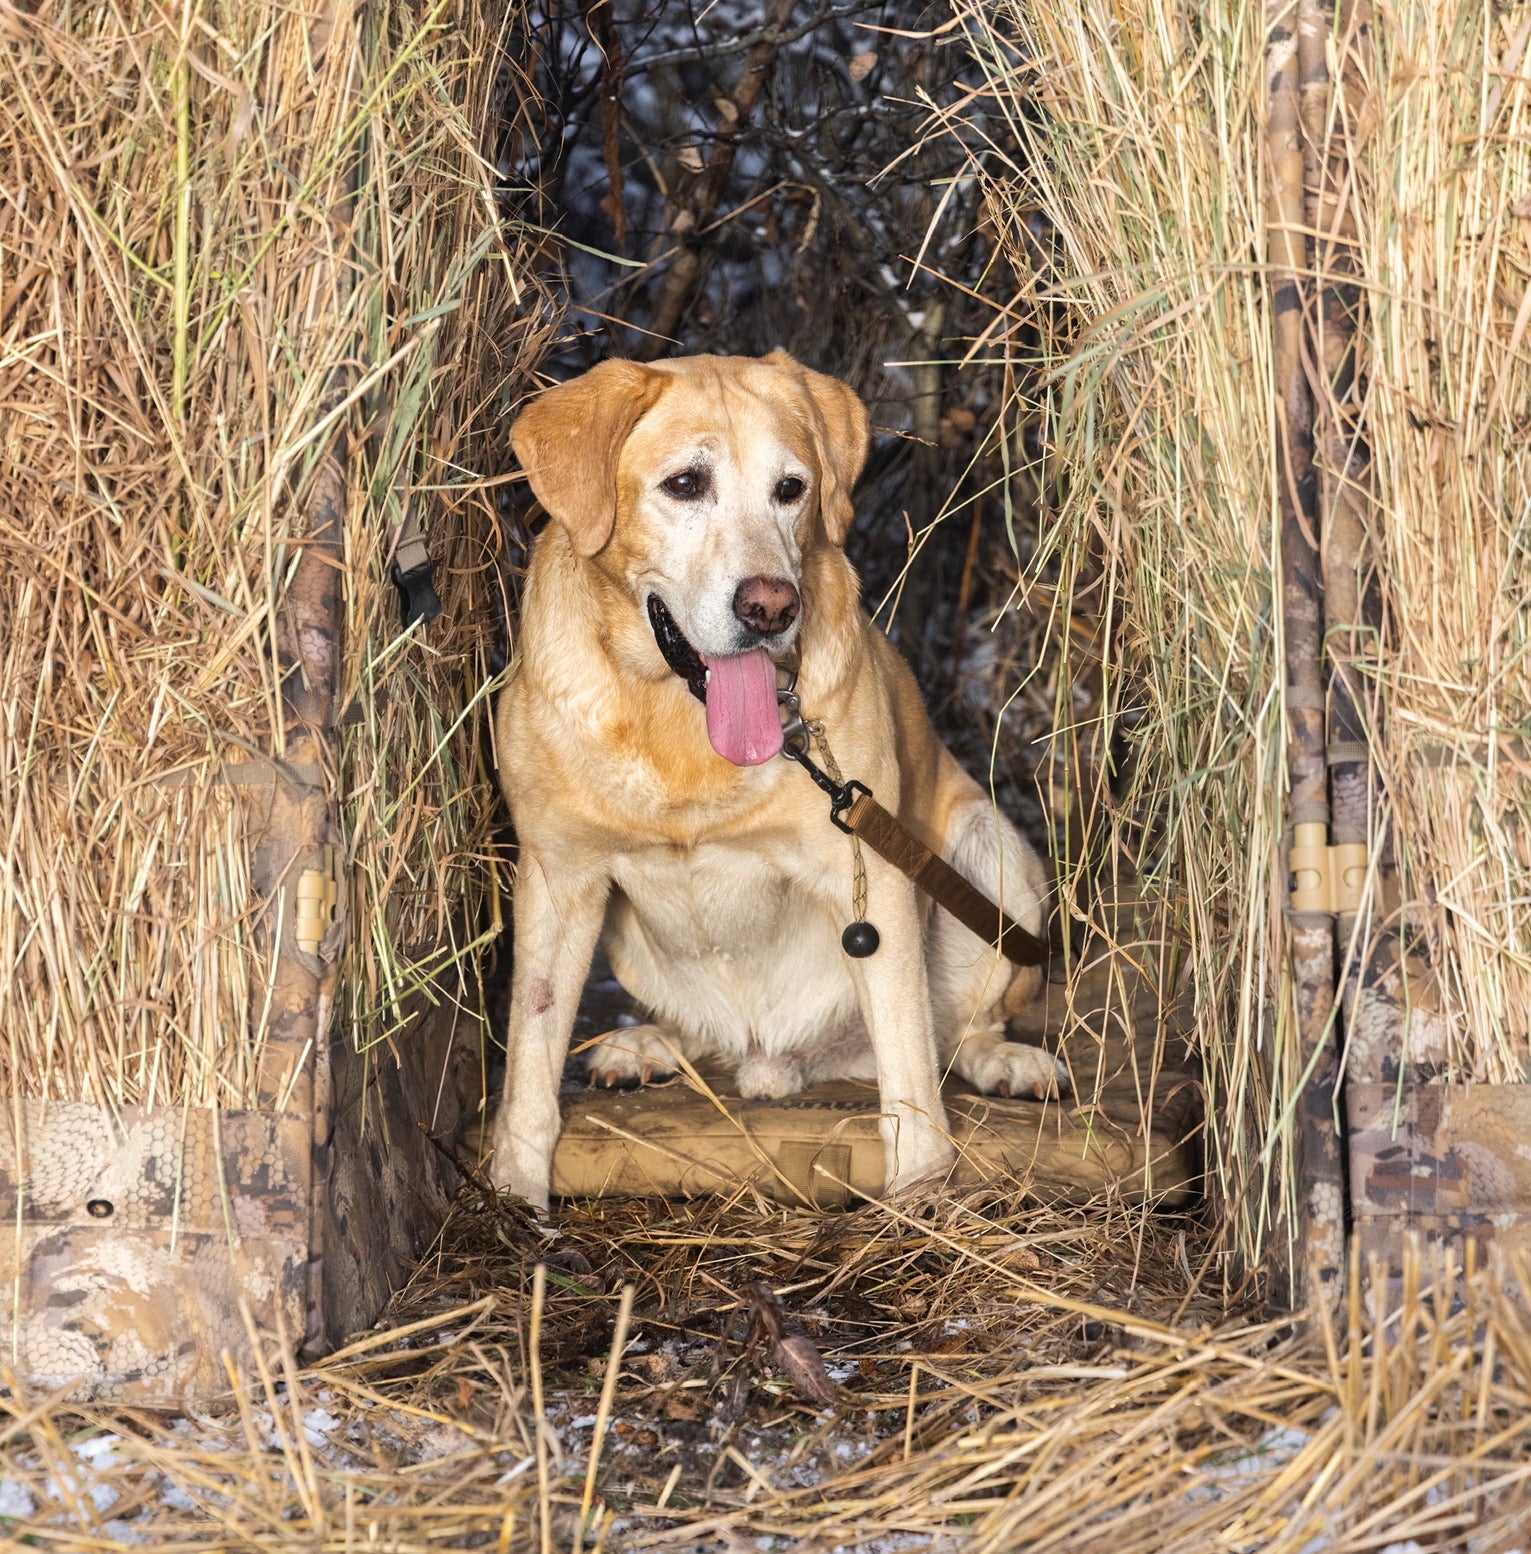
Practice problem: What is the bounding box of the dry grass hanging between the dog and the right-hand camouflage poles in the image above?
[947,0,1299,1286]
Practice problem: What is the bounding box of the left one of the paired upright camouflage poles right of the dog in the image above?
[1265,0,1344,1304]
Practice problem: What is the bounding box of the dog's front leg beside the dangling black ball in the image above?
[850,858,956,1192]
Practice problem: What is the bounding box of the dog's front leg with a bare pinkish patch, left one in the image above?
[490,853,609,1209]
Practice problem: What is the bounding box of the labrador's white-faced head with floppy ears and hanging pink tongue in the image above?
[511,351,869,765]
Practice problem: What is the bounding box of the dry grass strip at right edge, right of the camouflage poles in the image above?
[1360,0,1531,1082]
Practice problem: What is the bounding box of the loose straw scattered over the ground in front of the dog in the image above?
[0,1184,1531,1554]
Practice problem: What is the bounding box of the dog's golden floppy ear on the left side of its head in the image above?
[510,362,664,556]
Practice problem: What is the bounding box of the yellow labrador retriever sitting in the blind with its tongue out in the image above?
[493,351,1063,1207]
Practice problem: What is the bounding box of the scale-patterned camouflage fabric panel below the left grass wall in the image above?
[0,1100,312,1406]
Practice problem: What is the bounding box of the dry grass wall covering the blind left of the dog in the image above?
[0,0,544,1108]
